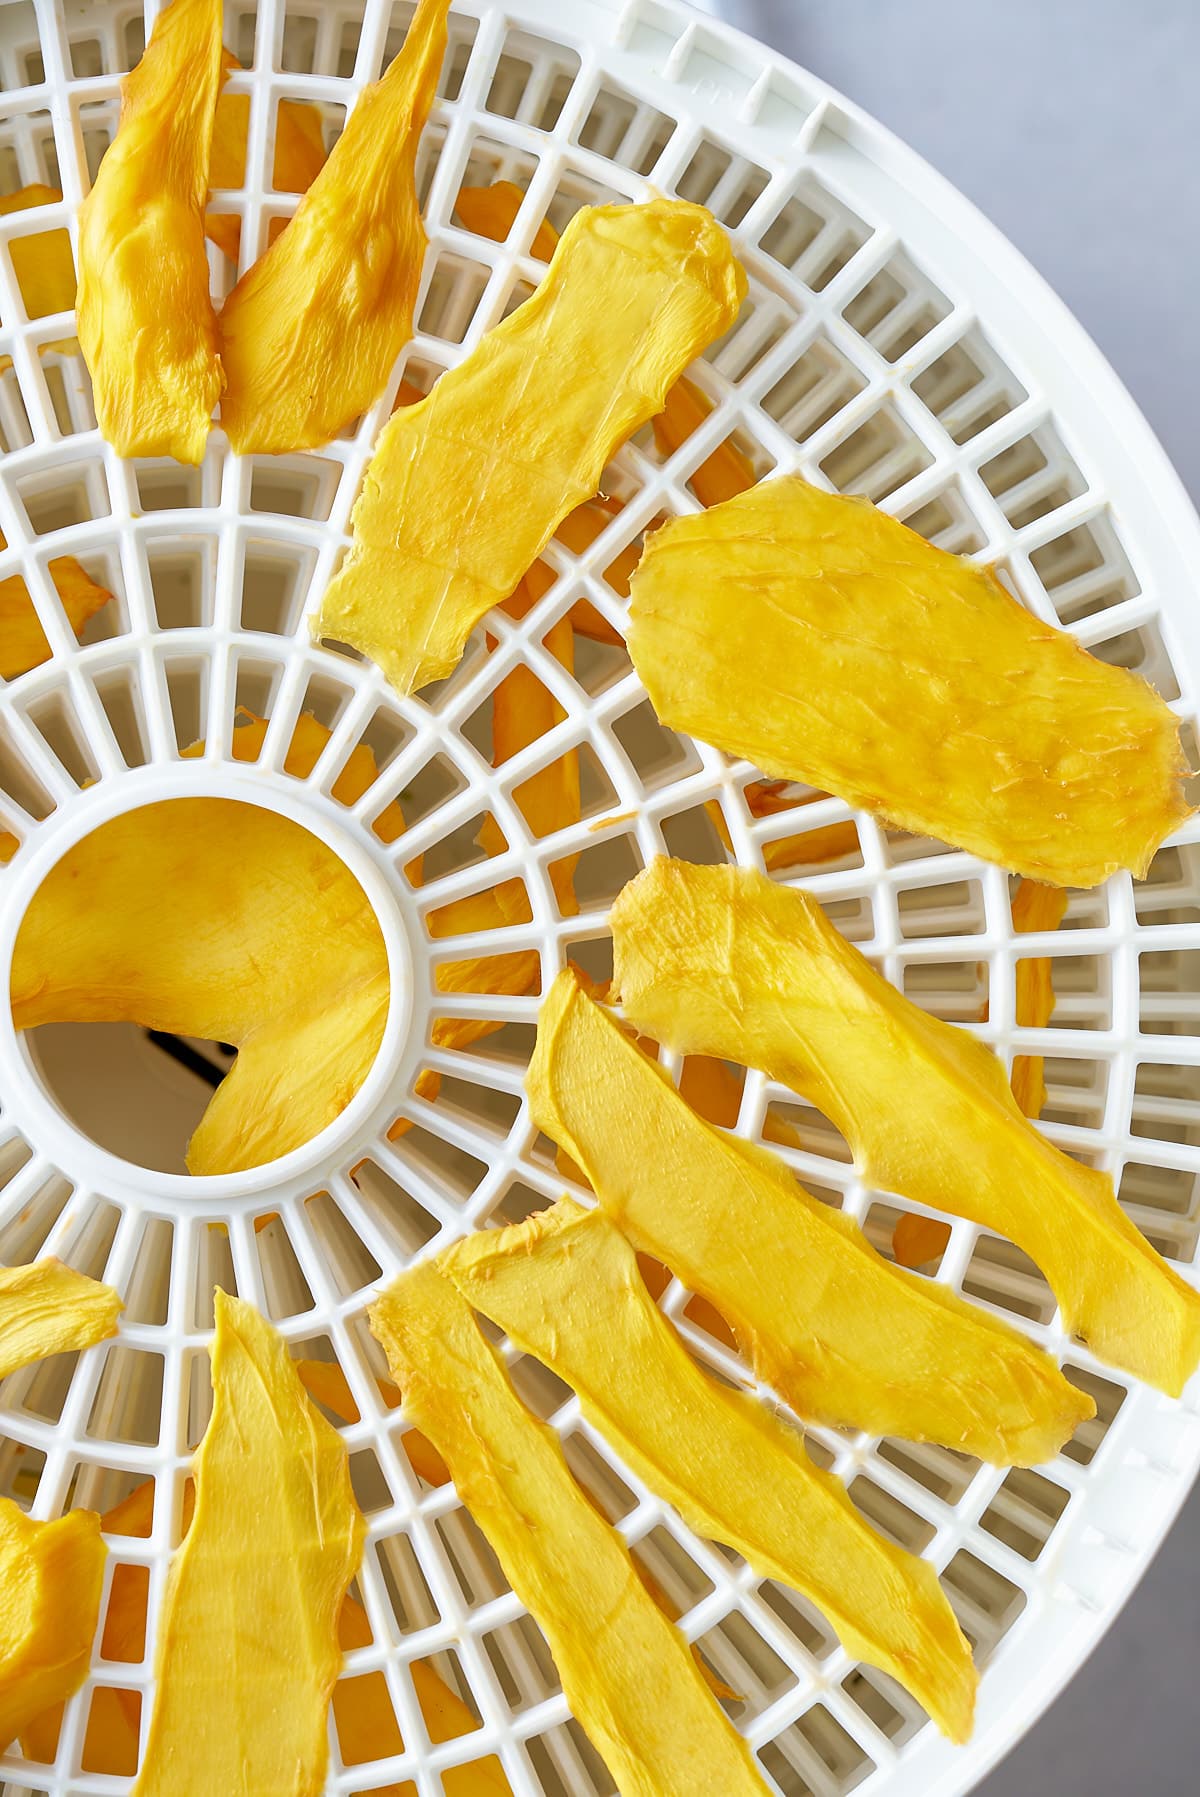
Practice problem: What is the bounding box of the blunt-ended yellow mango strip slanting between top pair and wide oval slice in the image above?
[312,199,746,694]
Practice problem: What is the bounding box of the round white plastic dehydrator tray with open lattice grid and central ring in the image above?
[0,0,1200,1797]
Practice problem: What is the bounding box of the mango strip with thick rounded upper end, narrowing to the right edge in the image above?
[613,859,1200,1394]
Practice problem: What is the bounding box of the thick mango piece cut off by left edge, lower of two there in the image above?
[0,1497,104,1752]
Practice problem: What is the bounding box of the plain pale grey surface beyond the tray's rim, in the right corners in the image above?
[693,0,1200,1797]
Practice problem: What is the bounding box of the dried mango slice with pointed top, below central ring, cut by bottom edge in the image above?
[135,1292,365,1797]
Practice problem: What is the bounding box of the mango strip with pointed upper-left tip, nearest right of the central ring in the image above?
[526,970,1092,1466]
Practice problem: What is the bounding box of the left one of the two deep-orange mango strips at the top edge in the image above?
[75,0,223,462]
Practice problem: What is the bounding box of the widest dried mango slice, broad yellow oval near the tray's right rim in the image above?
[629,476,1189,886]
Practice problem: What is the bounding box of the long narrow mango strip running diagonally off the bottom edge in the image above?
[370,1263,763,1797]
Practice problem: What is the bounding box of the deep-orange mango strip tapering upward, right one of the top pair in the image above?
[221,0,449,455]
